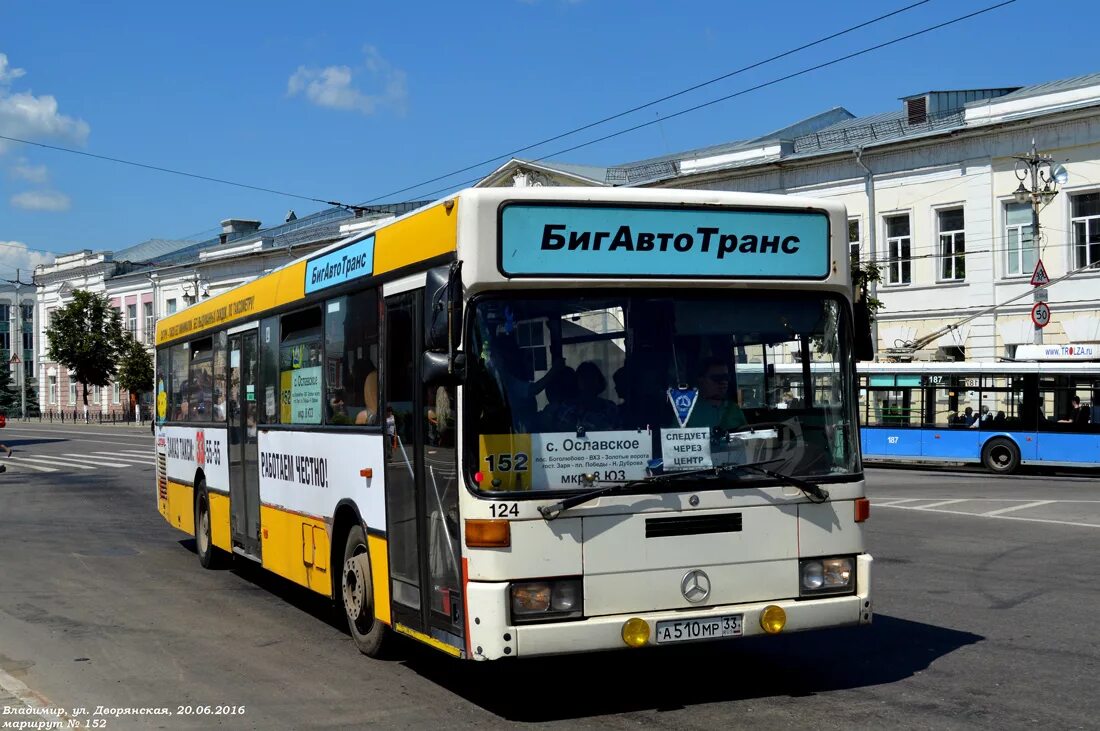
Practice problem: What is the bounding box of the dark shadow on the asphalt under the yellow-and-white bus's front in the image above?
[404,614,985,722]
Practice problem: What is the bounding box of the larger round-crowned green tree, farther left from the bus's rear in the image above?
[46,289,125,407]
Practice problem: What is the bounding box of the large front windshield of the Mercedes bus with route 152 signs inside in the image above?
[464,290,860,491]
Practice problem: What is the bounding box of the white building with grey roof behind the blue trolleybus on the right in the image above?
[480,74,1100,361]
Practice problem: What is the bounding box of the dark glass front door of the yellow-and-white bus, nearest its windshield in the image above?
[383,290,465,651]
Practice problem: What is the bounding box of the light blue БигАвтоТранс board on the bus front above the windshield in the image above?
[499,203,829,279]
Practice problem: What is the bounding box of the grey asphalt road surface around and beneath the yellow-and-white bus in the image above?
[0,425,1100,729]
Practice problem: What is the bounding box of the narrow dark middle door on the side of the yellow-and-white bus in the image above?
[229,330,261,560]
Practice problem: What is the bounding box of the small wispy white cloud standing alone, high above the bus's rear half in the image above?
[286,46,408,114]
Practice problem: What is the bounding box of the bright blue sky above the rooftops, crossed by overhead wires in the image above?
[0,0,1100,278]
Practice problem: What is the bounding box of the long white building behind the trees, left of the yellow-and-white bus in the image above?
[32,201,424,418]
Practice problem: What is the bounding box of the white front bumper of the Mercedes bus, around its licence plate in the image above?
[468,554,873,660]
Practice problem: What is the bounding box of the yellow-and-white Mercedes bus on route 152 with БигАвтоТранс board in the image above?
[156,188,871,660]
